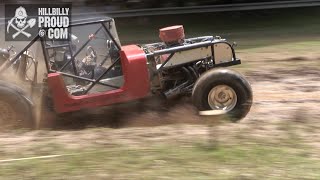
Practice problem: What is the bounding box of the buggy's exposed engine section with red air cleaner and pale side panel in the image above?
[142,25,234,97]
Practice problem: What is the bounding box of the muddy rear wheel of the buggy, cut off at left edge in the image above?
[0,86,34,130]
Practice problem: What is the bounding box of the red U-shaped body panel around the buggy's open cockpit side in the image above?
[48,45,150,113]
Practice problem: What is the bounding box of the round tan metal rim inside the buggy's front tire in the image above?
[208,85,237,112]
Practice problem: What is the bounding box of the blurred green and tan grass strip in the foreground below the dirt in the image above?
[0,139,320,179]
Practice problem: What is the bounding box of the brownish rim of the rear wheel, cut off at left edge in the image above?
[0,101,16,128]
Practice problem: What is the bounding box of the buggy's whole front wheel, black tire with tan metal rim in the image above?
[192,69,252,122]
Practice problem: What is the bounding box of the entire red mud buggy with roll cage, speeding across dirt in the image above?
[0,18,252,128]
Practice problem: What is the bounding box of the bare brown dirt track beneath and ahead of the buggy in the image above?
[0,50,320,154]
